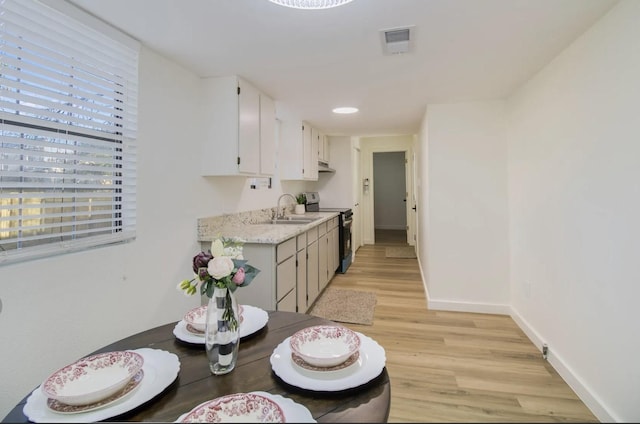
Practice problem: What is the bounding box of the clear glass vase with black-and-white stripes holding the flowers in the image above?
[205,287,240,375]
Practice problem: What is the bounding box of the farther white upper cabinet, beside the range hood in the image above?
[276,102,318,181]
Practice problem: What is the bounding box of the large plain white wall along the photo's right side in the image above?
[508,0,640,422]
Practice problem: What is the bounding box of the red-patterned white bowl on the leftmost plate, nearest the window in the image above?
[41,351,144,406]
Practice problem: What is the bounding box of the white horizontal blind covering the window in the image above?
[0,0,139,264]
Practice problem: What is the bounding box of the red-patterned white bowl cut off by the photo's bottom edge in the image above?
[179,393,285,423]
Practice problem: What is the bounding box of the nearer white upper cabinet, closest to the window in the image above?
[201,75,276,176]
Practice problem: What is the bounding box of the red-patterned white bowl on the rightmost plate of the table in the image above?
[289,325,360,367]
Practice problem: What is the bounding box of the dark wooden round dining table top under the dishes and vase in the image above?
[3,311,391,423]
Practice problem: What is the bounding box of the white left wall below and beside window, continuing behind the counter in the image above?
[0,44,305,417]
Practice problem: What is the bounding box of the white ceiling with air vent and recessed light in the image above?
[69,0,616,135]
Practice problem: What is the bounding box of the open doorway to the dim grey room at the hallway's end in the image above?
[373,151,408,243]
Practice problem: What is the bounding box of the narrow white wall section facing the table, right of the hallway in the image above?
[420,101,509,313]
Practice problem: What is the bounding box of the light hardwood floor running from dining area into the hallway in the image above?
[328,231,598,423]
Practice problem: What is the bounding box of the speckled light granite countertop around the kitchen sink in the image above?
[198,210,339,244]
